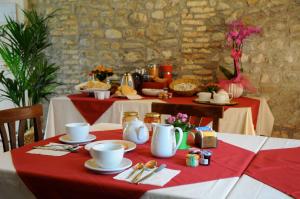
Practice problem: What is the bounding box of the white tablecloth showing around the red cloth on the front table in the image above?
[0,124,266,199]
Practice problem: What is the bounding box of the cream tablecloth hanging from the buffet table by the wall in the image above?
[45,96,274,137]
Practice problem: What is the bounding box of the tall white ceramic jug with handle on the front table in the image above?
[151,124,183,158]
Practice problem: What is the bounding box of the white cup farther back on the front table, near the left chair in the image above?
[65,123,90,141]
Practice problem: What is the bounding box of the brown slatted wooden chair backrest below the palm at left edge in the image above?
[0,104,43,152]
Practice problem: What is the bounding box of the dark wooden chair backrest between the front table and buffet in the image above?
[152,103,224,131]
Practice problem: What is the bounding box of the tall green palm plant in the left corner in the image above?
[0,10,59,142]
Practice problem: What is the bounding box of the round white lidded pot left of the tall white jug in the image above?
[123,118,149,144]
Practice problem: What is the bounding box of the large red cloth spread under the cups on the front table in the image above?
[11,130,254,199]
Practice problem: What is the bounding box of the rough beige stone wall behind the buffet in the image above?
[29,0,300,136]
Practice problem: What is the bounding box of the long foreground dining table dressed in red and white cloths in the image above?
[0,123,300,199]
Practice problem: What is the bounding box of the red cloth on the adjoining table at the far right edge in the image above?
[246,147,300,198]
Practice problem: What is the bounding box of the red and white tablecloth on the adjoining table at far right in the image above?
[228,138,300,199]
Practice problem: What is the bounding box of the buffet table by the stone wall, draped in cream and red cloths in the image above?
[45,95,274,137]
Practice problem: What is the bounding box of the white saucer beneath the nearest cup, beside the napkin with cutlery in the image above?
[84,158,132,174]
